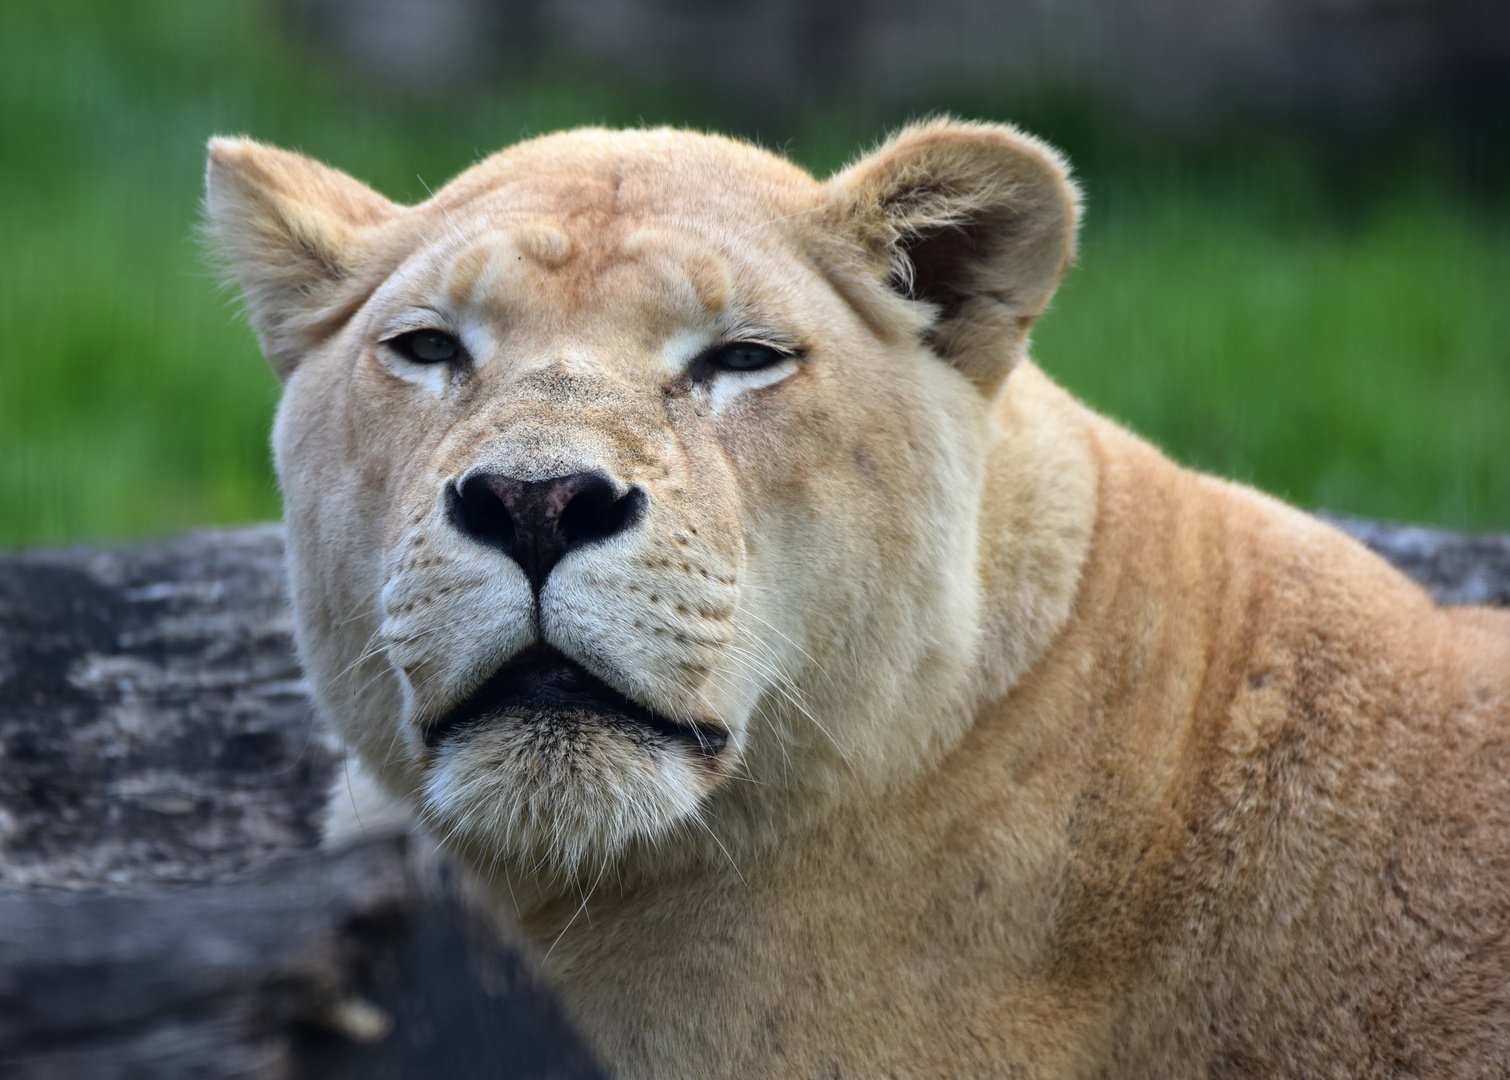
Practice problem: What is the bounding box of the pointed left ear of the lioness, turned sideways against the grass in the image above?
[205,139,402,379]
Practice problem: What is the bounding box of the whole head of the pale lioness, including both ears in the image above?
[208,124,1074,873]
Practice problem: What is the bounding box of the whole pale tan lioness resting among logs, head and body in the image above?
[208,121,1510,1078]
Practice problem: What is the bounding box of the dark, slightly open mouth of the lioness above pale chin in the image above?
[424,645,729,757]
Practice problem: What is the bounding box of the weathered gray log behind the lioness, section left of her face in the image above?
[0,526,340,887]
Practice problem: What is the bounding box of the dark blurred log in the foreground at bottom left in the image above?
[0,841,601,1080]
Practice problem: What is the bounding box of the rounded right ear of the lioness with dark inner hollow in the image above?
[829,119,1080,394]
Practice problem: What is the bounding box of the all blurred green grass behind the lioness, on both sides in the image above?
[0,0,1510,545]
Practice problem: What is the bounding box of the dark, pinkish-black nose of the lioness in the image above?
[447,473,645,592]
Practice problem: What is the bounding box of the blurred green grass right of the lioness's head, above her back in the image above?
[1036,182,1510,529]
